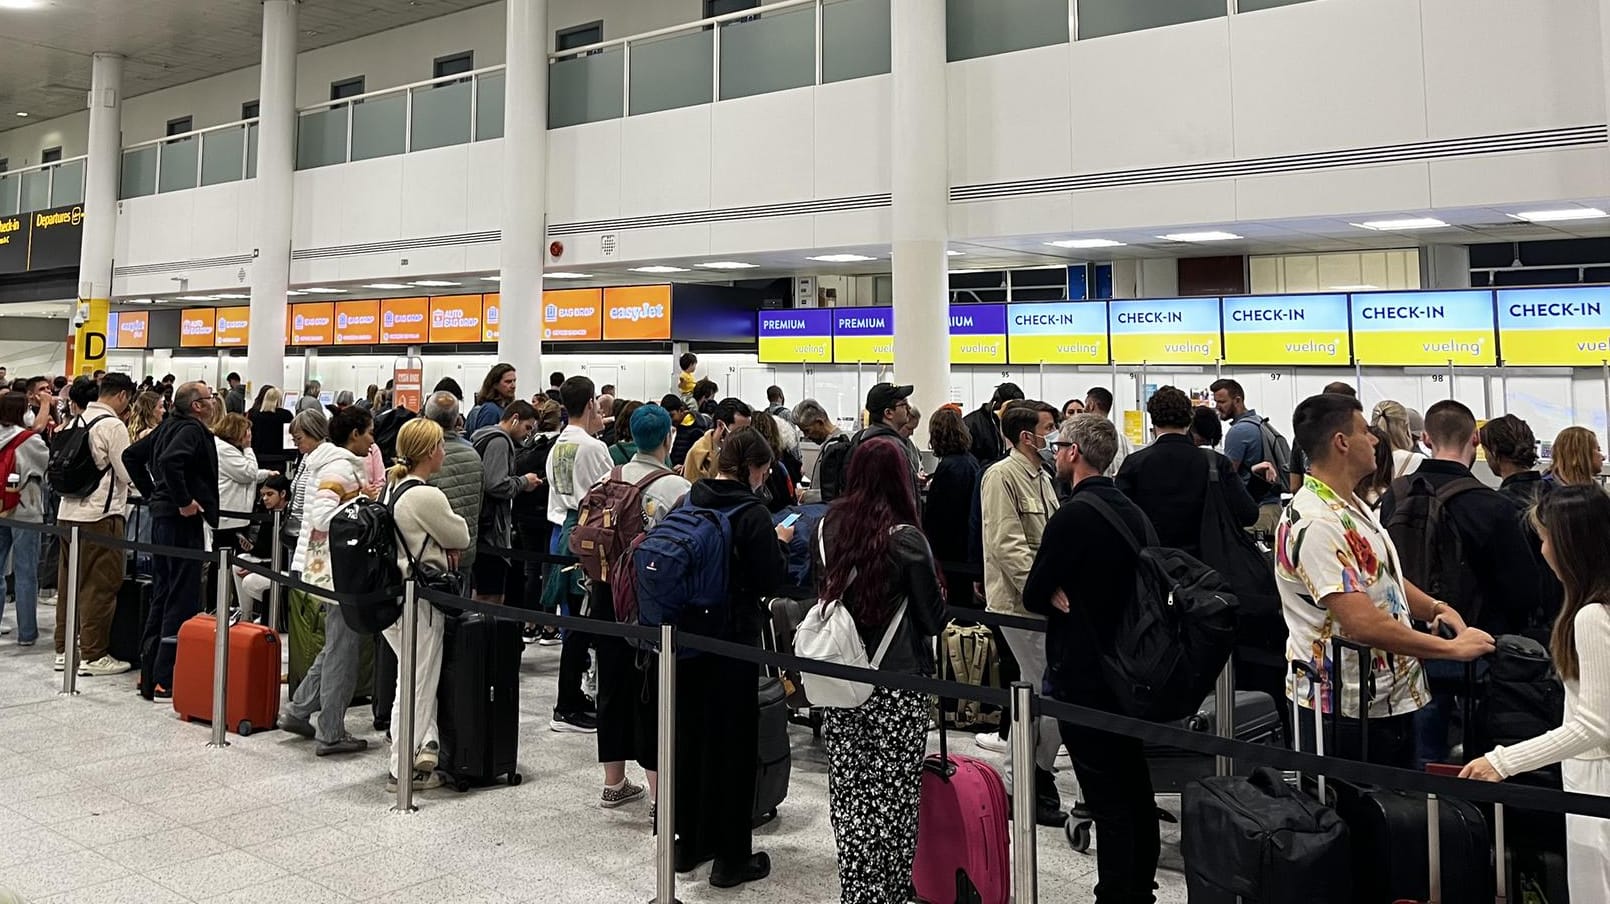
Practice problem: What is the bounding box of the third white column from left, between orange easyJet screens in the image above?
[497,0,547,381]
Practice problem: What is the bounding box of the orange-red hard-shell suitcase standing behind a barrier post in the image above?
[174,614,280,735]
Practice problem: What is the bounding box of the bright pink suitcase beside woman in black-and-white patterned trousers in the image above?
[911,725,1011,904]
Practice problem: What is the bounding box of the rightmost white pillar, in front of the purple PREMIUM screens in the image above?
[888,0,950,446]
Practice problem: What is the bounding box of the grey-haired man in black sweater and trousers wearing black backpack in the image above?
[1030,414,1159,901]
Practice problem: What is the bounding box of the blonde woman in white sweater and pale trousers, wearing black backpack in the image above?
[383,417,470,791]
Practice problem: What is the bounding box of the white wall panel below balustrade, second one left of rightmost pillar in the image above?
[710,89,816,208]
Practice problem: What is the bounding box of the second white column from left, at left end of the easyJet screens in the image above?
[245,0,301,395]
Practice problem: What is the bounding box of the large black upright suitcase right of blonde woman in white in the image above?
[435,611,525,791]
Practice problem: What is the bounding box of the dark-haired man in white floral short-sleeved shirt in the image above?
[1275,393,1492,767]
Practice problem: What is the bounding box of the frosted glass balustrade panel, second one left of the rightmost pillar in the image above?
[721,6,816,100]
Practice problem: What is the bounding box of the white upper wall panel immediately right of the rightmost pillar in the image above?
[947,44,1074,185]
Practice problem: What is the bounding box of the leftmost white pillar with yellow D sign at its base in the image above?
[68,53,122,375]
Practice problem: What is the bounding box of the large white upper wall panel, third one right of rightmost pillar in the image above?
[1228,0,1423,156]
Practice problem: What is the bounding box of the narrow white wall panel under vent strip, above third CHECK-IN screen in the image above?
[1235,163,1431,219]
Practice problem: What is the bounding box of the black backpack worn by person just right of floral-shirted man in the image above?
[1386,474,1486,625]
